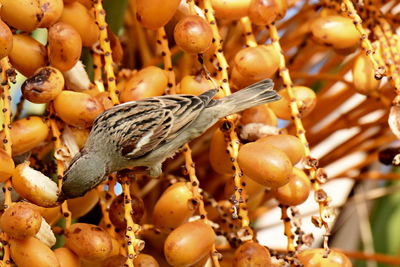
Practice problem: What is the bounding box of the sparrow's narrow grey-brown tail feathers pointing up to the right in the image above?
[217,79,281,116]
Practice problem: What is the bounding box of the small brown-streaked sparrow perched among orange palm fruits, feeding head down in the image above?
[58,79,280,202]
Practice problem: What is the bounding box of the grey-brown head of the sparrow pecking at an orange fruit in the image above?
[58,150,107,202]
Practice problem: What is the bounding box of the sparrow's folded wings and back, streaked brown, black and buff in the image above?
[91,92,217,159]
